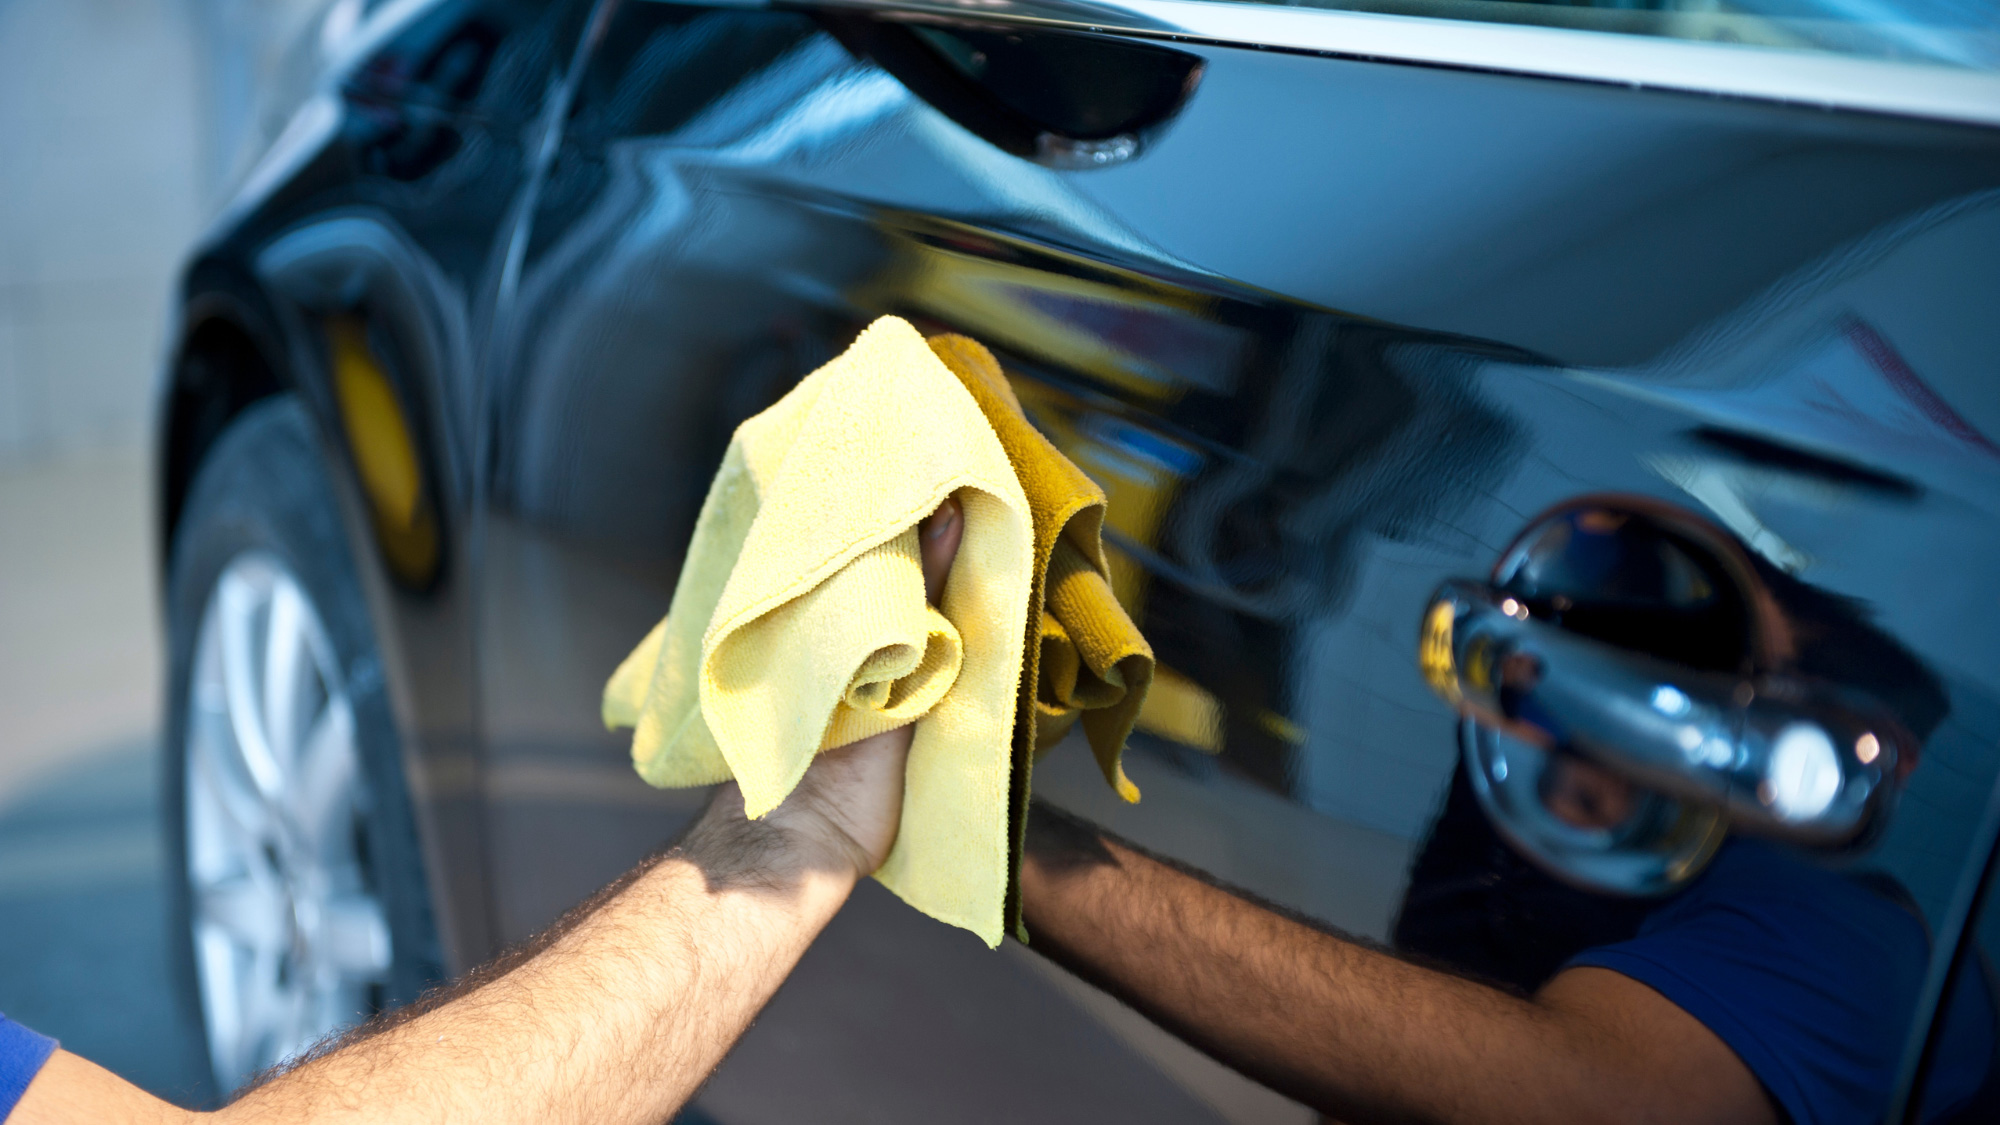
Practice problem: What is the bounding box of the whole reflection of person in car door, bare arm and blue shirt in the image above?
[1022,712,2000,1125]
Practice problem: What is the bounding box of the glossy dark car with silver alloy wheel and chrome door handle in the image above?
[158,0,2000,1123]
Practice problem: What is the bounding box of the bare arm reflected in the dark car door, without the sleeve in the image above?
[1020,805,1776,1123]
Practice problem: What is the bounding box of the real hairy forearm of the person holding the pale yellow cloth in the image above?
[220,796,854,1123]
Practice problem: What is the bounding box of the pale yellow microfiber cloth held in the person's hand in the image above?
[604,316,1032,945]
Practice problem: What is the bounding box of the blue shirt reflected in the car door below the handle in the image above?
[1570,839,1994,1125]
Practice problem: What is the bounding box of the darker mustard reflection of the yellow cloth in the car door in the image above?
[930,336,1154,935]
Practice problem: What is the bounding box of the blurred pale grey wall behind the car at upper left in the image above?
[0,0,340,468]
